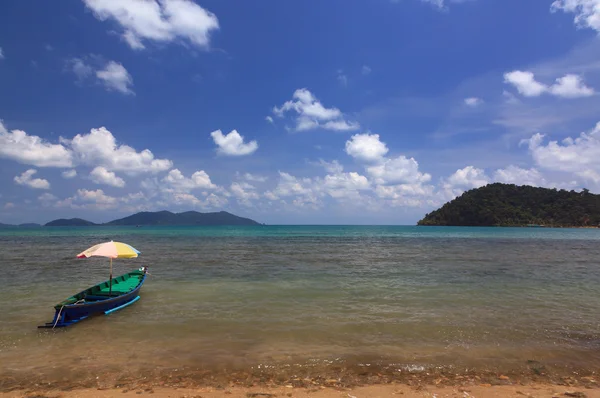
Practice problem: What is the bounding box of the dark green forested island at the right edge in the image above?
[417,183,600,227]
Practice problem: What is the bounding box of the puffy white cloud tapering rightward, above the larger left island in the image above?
[70,127,173,174]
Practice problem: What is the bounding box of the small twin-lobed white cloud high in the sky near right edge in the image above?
[504,70,594,98]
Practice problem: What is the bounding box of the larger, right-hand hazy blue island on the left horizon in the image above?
[105,211,260,225]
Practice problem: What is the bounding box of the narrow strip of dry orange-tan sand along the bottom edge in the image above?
[0,384,600,398]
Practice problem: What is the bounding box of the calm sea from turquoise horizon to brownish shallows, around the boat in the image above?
[0,226,600,391]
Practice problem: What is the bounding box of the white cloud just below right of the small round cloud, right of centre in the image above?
[367,156,431,185]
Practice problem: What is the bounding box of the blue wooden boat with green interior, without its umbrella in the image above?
[38,267,148,329]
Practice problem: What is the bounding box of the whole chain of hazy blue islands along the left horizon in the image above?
[45,210,261,227]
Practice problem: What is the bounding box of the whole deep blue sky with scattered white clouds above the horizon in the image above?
[0,0,600,224]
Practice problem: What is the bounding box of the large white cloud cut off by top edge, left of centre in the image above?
[83,0,219,50]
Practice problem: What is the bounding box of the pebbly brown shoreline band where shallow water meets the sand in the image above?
[0,369,600,398]
